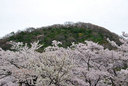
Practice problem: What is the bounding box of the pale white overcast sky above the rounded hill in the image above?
[0,0,128,37]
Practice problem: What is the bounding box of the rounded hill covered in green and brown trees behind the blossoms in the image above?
[0,22,120,51]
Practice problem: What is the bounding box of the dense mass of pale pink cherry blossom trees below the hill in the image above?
[0,32,128,86]
